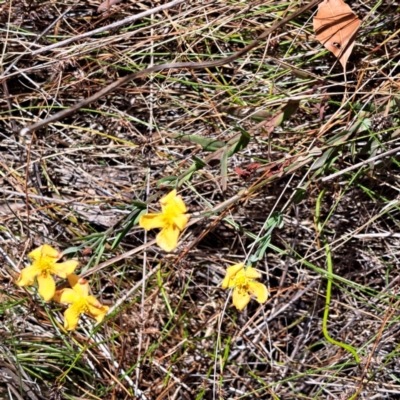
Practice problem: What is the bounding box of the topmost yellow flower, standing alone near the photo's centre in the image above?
[139,190,190,252]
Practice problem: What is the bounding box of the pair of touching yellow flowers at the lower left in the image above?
[16,244,108,330]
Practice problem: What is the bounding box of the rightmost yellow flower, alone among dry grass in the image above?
[222,264,268,311]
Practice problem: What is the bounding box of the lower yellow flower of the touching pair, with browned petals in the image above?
[53,274,108,331]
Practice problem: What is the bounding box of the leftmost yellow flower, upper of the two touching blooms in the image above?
[16,244,78,301]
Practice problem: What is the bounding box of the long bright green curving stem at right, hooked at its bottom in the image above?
[315,189,360,364]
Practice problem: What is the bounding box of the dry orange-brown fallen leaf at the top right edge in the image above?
[313,0,361,70]
